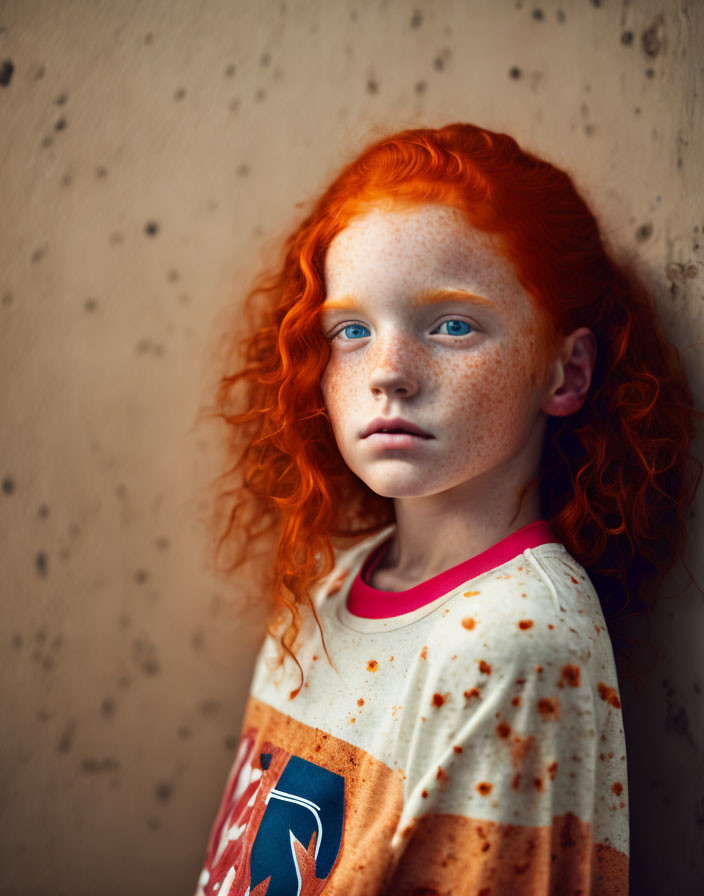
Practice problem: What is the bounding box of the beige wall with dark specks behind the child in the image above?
[0,0,704,896]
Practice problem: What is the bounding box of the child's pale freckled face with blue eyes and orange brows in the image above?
[320,204,546,498]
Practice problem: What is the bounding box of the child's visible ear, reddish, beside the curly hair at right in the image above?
[540,327,596,417]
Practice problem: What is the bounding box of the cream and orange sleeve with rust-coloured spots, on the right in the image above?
[388,556,628,896]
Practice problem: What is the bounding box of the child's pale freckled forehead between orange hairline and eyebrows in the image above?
[325,203,536,322]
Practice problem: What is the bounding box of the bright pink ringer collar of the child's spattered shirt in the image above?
[347,520,557,619]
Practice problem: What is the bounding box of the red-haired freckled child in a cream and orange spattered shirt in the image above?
[191,124,698,896]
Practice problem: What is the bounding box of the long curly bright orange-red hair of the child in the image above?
[206,124,704,696]
